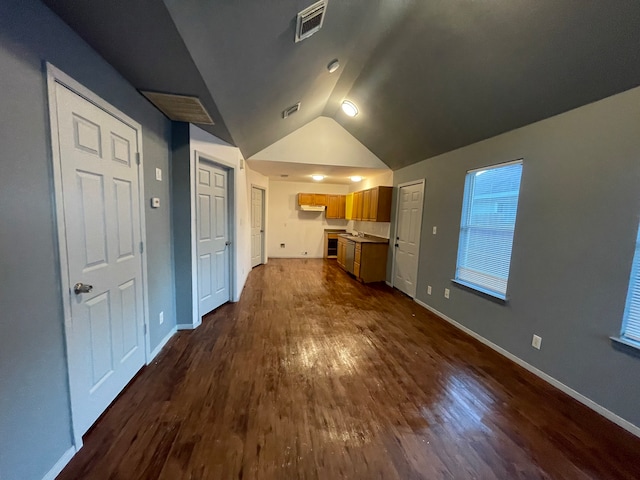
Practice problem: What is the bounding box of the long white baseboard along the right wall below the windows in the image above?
[414,298,640,437]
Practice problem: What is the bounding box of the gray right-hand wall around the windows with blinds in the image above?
[389,85,640,426]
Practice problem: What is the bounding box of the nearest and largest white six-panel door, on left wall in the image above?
[54,83,145,433]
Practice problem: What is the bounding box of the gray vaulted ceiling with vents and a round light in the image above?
[44,0,640,169]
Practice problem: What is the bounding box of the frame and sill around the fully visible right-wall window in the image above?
[451,158,524,304]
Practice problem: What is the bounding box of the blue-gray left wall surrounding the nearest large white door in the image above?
[0,0,175,480]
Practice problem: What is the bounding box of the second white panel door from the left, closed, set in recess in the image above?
[196,160,231,317]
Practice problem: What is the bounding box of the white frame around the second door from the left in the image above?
[189,150,237,330]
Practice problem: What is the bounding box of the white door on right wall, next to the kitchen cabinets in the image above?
[393,182,424,298]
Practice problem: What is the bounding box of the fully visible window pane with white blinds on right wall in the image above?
[455,160,522,300]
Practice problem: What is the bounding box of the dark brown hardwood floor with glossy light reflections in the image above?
[58,260,640,480]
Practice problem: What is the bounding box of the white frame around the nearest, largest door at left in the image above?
[46,62,151,451]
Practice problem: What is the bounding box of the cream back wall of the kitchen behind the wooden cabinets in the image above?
[267,181,349,258]
